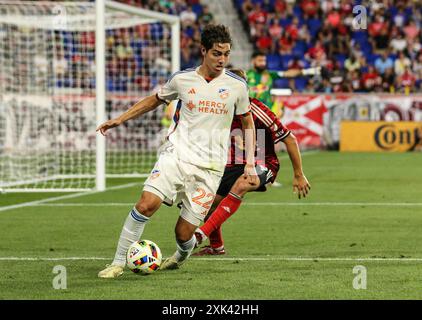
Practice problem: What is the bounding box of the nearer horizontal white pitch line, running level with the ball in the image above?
[0,256,422,262]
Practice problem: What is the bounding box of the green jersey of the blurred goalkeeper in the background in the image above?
[247,69,278,108]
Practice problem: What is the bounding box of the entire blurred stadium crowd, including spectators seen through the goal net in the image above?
[0,0,422,93]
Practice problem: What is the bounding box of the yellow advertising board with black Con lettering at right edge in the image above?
[340,121,422,152]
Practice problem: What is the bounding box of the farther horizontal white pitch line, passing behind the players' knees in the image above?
[33,202,422,207]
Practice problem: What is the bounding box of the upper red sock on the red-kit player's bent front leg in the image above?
[200,193,242,238]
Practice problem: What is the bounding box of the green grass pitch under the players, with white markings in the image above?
[0,152,422,300]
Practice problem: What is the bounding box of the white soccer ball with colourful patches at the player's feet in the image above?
[126,240,162,274]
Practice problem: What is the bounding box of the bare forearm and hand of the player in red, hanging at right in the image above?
[283,133,311,199]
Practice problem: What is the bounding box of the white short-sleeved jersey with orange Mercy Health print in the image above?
[157,67,250,174]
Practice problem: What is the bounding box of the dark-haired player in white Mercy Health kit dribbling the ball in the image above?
[97,25,259,278]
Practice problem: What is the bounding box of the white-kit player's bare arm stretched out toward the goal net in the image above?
[96,94,163,136]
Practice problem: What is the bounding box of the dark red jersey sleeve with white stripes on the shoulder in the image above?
[251,98,290,144]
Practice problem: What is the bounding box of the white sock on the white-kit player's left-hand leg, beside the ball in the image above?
[112,207,149,267]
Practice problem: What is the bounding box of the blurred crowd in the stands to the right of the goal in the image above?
[233,0,422,93]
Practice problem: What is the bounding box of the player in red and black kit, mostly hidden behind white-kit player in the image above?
[193,69,311,255]
